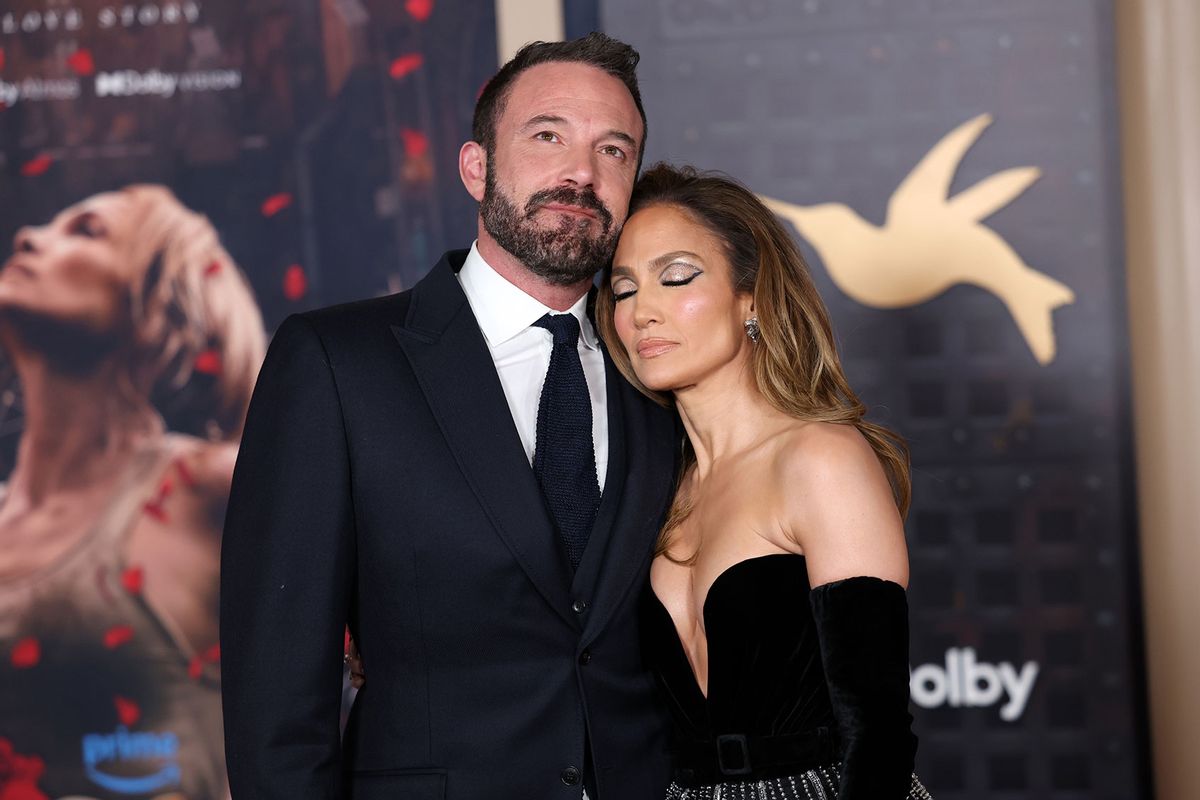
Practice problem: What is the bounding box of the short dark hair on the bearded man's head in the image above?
[470,31,646,166]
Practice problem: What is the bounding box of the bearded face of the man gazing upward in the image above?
[480,62,642,285]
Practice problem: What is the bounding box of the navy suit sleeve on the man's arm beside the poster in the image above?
[221,315,354,800]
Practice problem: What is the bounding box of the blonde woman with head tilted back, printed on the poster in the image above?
[0,186,265,799]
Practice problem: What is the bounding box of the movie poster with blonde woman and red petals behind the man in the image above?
[0,0,497,800]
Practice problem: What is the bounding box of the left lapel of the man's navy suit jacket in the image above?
[392,253,578,626]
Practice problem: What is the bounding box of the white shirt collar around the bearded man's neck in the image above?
[458,241,600,350]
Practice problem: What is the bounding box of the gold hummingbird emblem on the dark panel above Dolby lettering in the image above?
[762,114,1075,365]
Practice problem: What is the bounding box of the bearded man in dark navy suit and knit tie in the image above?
[221,34,676,800]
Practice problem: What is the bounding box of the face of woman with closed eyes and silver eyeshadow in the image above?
[611,205,752,391]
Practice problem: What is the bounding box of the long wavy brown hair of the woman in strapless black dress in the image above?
[596,163,911,563]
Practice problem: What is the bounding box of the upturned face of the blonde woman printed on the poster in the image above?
[0,193,137,333]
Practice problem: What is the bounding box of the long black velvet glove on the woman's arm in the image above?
[809,577,917,800]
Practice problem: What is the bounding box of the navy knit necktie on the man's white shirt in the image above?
[533,313,600,569]
